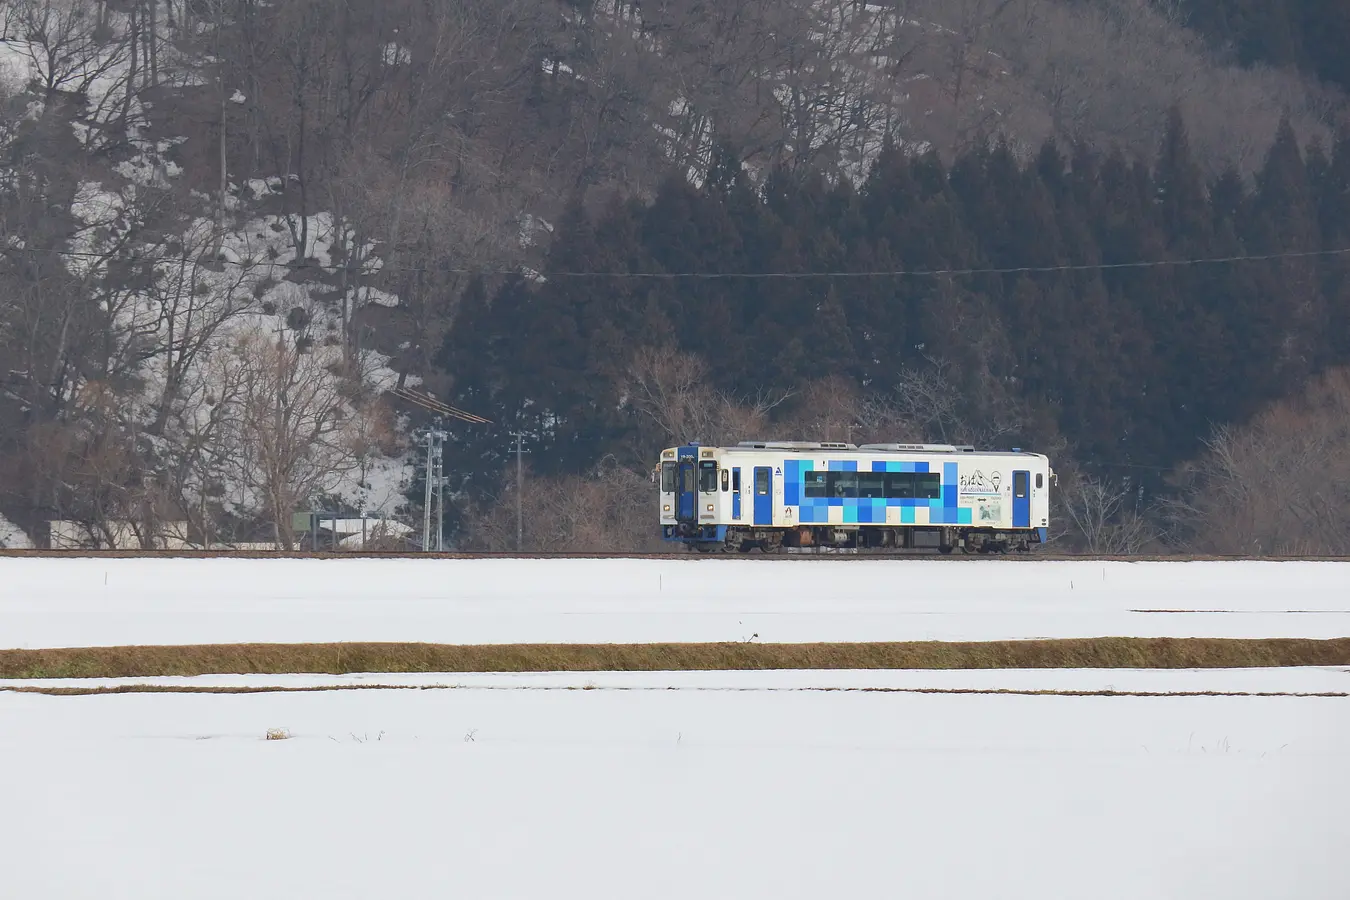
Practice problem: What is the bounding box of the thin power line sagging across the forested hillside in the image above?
[0,241,1350,281]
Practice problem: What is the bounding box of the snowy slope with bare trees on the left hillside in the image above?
[0,0,420,540]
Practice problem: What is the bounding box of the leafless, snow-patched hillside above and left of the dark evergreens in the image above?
[0,0,1342,542]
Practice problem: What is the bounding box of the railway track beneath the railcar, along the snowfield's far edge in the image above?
[0,549,1350,563]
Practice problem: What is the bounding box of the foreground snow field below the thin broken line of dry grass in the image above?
[0,673,1350,900]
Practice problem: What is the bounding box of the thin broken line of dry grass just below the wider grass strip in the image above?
[0,684,1350,701]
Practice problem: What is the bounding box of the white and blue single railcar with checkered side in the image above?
[657,441,1054,553]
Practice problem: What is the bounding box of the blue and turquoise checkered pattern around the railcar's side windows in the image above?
[783,459,972,525]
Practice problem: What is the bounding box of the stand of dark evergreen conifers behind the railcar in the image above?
[437,115,1350,553]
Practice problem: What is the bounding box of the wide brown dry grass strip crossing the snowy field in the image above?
[0,637,1350,679]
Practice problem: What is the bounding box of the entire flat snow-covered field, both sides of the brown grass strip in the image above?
[0,557,1350,900]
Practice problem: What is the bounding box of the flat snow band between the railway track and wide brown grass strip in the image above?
[0,557,1350,648]
